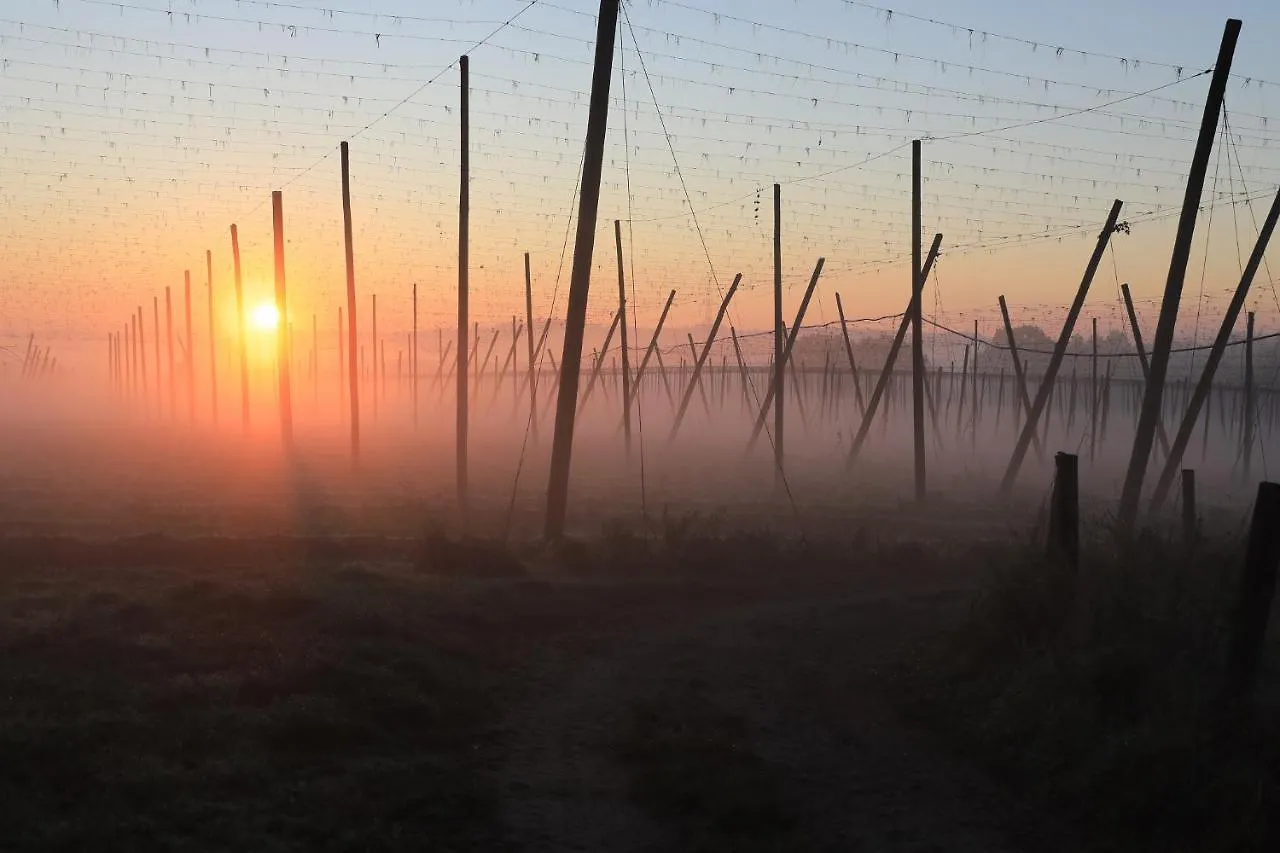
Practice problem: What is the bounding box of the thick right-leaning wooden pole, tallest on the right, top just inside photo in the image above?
[1116,18,1240,530]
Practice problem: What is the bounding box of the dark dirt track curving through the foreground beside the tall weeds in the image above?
[494,578,1080,852]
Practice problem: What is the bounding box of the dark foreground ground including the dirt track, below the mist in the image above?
[0,539,1080,850]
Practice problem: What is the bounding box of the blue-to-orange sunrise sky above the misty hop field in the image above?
[0,0,1280,366]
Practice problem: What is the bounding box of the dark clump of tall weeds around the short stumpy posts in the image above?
[909,533,1280,850]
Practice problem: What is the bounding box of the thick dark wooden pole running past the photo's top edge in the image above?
[545,0,618,539]
